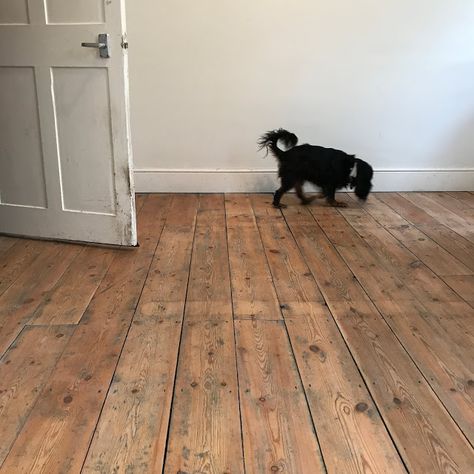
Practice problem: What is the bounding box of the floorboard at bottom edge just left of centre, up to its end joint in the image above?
[164,315,244,474]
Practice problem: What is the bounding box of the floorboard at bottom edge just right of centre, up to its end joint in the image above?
[235,320,325,474]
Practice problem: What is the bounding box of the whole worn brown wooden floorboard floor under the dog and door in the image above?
[0,192,474,474]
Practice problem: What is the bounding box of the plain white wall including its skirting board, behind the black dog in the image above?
[127,0,474,191]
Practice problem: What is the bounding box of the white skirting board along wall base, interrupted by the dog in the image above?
[135,168,474,193]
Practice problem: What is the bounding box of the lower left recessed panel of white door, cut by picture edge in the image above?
[0,67,46,207]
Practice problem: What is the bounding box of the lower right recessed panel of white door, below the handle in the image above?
[53,68,115,214]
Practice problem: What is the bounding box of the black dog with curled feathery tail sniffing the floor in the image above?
[258,128,374,207]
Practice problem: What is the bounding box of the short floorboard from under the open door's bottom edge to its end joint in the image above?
[30,247,115,325]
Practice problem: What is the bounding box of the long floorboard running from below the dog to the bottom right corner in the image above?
[284,209,474,472]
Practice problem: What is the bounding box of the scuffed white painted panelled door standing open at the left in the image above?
[0,0,137,245]
